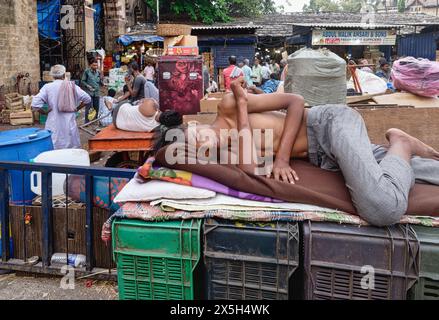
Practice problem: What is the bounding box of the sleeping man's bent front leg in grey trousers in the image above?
[321,107,414,226]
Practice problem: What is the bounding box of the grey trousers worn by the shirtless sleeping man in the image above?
[307,105,439,226]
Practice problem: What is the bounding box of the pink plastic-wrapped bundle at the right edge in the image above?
[391,57,439,97]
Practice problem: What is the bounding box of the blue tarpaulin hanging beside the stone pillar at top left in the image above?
[37,0,61,40]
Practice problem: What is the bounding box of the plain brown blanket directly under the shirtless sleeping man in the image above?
[155,147,439,216]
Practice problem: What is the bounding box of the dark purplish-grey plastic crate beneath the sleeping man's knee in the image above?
[303,221,419,300]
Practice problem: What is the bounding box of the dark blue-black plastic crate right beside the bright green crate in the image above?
[204,219,299,300]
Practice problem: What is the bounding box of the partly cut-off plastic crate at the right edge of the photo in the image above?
[409,226,439,300]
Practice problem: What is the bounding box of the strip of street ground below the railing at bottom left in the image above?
[0,273,118,300]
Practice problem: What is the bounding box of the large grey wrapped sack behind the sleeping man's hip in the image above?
[285,48,346,106]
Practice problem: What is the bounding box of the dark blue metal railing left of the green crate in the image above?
[0,162,135,275]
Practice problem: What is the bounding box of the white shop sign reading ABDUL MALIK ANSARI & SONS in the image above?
[312,30,396,46]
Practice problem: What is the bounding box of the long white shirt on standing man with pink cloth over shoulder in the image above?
[32,80,91,149]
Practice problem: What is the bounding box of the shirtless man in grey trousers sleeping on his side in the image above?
[156,77,439,226]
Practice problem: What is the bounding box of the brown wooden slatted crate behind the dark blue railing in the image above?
[10,206,116,269]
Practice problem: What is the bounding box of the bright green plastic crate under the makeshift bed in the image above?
[113,220,202,300]
